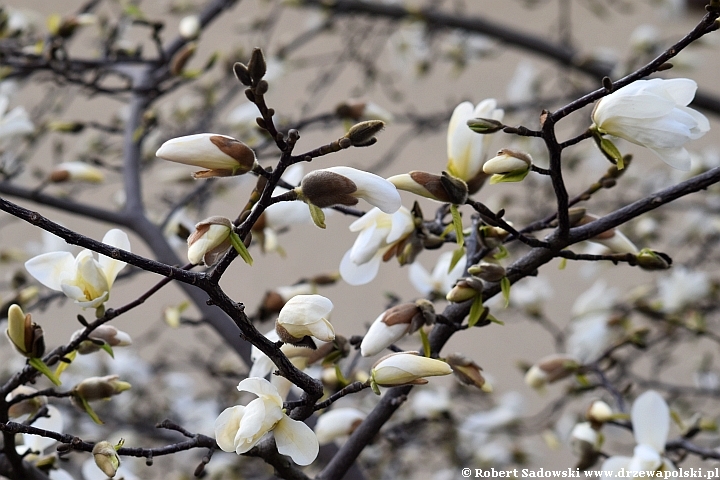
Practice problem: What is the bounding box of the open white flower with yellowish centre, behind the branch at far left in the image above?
[25,228,130,308]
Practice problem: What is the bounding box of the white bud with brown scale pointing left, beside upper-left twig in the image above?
[155,133,257,178]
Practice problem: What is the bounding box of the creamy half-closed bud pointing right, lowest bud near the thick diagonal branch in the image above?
[370,352,452,387]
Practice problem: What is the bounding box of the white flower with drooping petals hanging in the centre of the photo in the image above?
[340,206,415,285]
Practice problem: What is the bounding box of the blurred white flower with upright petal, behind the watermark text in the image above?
[600,390,675,478]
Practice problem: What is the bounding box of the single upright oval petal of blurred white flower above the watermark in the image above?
[631,390,670,453]
